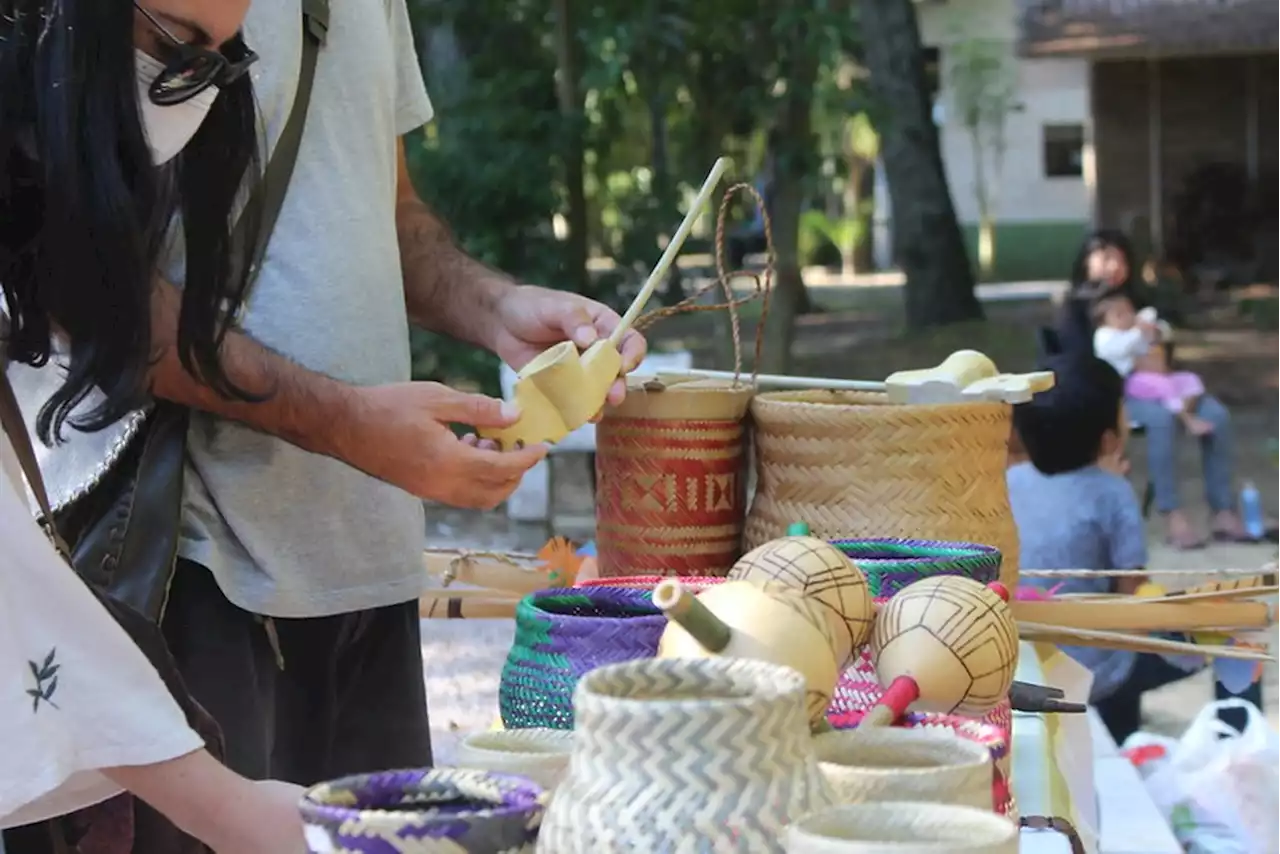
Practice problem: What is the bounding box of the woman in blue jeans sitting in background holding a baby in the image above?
[1059,230,1249,549]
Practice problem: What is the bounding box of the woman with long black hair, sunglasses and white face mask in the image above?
[0,0,303,854]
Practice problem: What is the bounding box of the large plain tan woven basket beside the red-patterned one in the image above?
[745,391,1018,590]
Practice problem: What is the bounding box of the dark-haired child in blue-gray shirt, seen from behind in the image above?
[1006,353,1199,743]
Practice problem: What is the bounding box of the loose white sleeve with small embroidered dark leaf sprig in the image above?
[0,425,205,828]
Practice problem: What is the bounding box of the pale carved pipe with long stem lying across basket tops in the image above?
[658,350,1053,405]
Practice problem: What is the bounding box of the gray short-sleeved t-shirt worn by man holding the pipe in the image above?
[166,0,431,617]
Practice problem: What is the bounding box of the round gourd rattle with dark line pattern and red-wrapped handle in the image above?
[861,575,1018,726]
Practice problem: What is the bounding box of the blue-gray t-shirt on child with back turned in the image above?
[1006,462,1147,703]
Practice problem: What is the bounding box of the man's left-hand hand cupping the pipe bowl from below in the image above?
[337,383,547,510]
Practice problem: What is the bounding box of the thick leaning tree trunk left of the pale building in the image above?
[859,0,983,329]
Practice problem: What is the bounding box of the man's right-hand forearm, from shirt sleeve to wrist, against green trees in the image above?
[396,193,513,348]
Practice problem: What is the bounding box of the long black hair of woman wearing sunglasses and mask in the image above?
[0,0,262,443]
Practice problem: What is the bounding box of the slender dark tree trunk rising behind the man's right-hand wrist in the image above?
[554,0,590,293]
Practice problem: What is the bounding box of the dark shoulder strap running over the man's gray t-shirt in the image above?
[232,0,329,306]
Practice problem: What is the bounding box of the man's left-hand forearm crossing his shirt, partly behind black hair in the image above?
[151,280,355,458]
